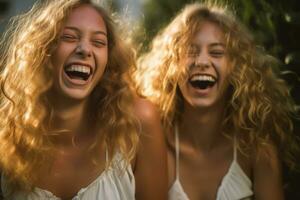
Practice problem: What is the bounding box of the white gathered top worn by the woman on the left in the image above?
[1,154,135,200]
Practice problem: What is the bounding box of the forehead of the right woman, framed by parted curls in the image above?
[192,21,224,45]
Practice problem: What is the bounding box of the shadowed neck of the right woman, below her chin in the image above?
[178,103,224,151]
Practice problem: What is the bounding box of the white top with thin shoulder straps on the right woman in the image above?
[169,127,253,200]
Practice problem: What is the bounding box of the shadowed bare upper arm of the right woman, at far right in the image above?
[254,145,284,200]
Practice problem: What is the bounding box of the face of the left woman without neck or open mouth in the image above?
[51,5,108,100]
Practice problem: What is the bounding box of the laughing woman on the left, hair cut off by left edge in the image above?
[0,0,167,200]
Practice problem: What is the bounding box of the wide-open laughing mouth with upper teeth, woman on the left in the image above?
[64,64,92,81]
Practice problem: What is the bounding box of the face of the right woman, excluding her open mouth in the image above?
[179,22,229,109]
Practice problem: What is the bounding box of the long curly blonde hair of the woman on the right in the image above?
[135,3,298,167]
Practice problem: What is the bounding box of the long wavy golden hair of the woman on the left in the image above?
[0,0,139,191]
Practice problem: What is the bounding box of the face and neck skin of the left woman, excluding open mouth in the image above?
[48,5,108,136]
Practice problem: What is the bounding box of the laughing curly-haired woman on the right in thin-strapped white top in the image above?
[136,3,296,200]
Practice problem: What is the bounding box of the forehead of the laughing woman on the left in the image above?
[65,4,106,32]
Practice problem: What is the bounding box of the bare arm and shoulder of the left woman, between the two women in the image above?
[134,99,168,200]
